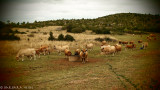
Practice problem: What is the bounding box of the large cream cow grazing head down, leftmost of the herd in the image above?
[16,48,36,61]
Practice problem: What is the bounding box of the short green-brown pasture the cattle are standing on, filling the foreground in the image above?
[0,26,160,90]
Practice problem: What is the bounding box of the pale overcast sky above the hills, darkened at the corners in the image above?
[0,0,160,22]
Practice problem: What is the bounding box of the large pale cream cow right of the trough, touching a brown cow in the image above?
[101,46,116,56]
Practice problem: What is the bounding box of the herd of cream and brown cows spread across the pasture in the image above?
[16,34,156,63]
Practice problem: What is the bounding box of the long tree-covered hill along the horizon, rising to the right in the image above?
[1,13,160,33]
